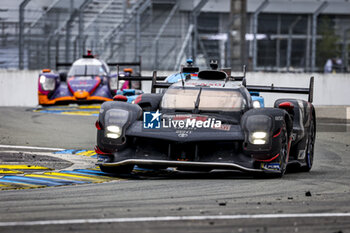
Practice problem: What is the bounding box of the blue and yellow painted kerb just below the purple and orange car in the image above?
[33,105,101,116]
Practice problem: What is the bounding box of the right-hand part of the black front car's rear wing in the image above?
[242,76,314,103]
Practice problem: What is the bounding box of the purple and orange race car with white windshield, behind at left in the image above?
[38,51,142,105]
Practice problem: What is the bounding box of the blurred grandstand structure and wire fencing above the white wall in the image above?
[0,0,350,73]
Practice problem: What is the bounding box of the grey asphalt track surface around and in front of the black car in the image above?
[0,108,350,232]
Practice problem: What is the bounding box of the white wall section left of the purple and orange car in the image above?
[0,70,40,106]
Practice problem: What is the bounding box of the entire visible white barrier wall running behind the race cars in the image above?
[0,70,350,106]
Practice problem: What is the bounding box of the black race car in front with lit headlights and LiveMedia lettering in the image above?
[96,68,316,177]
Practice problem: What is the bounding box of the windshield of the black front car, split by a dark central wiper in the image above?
[161,88,243,112]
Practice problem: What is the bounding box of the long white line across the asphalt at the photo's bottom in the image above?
[0,213,350,227]
